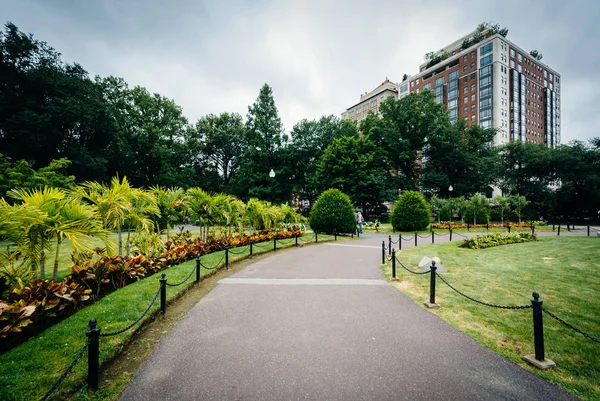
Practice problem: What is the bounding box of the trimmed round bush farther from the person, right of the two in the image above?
[390,191,431,231]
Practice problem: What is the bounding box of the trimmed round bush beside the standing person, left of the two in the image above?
[309,189,356,234]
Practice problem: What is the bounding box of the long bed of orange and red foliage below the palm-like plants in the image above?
[0,228,303,353]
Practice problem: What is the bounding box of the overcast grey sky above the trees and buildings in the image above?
[0,0,600,143]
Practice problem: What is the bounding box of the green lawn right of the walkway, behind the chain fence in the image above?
[381,237,600,400]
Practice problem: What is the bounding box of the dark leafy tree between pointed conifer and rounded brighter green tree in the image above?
[287,116,358,205]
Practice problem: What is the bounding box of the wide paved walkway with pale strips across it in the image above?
[121,235,574,401]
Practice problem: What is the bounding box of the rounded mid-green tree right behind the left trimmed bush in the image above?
[315,136,394,214]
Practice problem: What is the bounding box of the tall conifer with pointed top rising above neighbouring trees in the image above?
[235,84,292,202]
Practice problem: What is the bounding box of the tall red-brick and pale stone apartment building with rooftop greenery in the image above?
[398,30,560,147]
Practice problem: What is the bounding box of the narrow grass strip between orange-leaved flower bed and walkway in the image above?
[0,233,334,401]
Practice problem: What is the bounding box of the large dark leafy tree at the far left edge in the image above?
[0,23,113,179]
